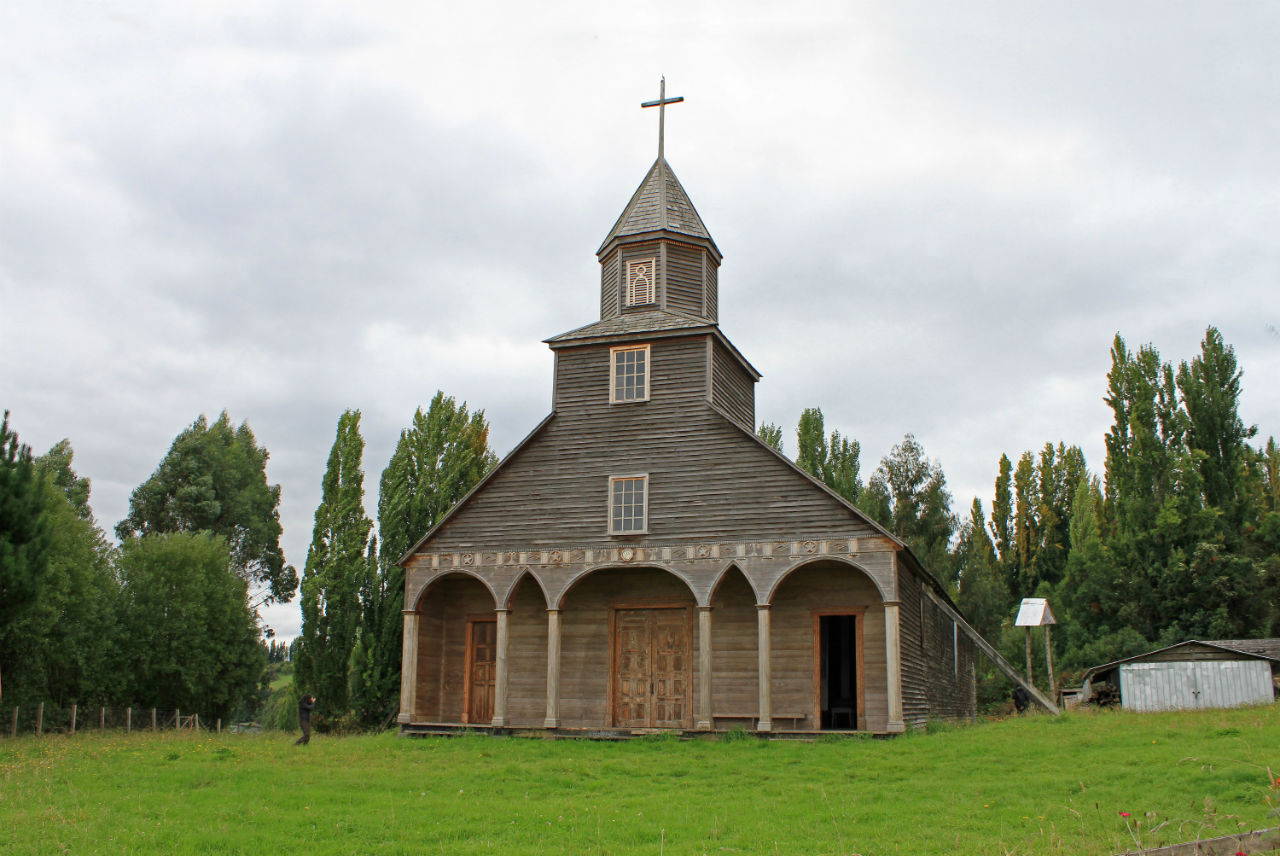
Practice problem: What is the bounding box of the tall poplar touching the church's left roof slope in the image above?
[356,392,498,723]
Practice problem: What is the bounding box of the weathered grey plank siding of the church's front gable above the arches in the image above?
[420,337,877,550]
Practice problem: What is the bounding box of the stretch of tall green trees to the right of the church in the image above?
[759,328,1280,700]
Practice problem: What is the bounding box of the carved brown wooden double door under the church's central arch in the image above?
[613,606,692,728]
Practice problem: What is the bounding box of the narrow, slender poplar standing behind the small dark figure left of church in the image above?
[294,411,372,723]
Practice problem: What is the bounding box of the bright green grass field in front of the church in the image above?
[0,705,1280,856]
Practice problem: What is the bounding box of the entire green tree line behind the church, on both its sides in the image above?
[0,328,1280,728]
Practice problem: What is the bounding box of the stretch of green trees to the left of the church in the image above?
[0,394,497,727]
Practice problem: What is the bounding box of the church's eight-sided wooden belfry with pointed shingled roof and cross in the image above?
[595,79,722,324]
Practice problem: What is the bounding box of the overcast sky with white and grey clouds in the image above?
[0,0,1280,636]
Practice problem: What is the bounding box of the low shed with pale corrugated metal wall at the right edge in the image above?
[1084,640,1280,711]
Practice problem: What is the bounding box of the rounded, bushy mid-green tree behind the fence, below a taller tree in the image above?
[119,532,265,718]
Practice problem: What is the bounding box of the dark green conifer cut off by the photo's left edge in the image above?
[0,411,49,695]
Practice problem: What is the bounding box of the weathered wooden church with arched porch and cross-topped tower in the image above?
[399,85,986,733]
